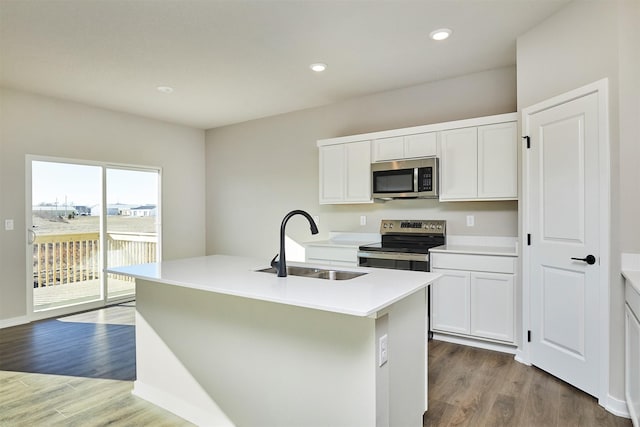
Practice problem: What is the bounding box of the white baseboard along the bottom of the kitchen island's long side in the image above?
[131,381,234,427]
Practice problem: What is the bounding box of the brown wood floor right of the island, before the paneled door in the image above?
[423,341,631,427]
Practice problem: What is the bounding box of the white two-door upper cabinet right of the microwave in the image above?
[440,122,518,201]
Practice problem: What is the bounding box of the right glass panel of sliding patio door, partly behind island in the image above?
[105,168,160,300]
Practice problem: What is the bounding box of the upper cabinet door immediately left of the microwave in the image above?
[345,141,371,202]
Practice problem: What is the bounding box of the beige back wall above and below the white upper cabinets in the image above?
[206,67,517,258]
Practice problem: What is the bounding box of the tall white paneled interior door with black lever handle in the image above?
[523,92,607,396]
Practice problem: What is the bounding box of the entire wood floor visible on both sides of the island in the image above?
[0,304,631,427]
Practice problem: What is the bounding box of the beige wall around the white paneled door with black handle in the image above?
[517,0,640,408]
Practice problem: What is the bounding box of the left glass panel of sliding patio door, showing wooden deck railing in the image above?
[30,161,103,312]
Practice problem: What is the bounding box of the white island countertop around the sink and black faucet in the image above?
[107,255,440,317]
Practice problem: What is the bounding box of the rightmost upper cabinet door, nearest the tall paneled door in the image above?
[478,122,518,199]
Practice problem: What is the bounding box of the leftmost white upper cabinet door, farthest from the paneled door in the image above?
[320,145,345,203]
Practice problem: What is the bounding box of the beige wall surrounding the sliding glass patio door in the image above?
[0,89,205,324]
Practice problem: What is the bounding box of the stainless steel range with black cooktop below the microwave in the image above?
[358,219,447,271]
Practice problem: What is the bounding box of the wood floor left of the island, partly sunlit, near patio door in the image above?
[0,304,192,427]
